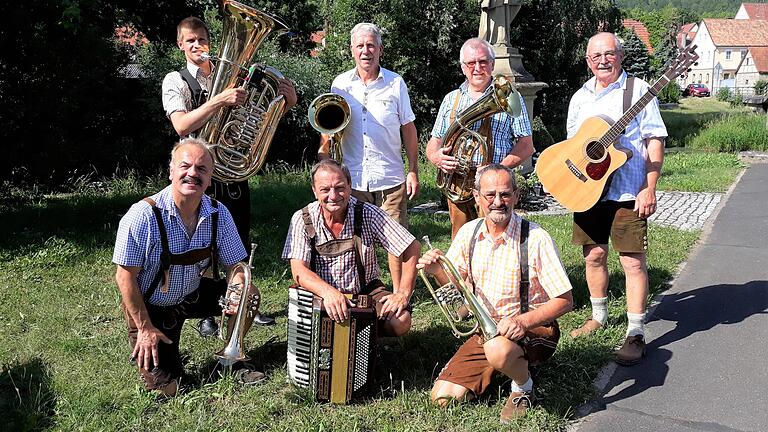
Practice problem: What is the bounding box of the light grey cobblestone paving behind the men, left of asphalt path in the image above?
[411,191,723,230]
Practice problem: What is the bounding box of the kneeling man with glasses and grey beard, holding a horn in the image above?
[417,164,573,422]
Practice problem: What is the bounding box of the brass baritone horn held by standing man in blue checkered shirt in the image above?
[436,75,522,203]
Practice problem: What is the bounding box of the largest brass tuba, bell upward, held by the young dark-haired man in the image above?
[198,0,288,183]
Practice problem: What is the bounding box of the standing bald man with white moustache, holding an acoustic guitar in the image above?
[567,33,667,365]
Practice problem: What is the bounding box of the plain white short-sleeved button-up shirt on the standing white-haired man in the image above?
[331,68,416,191]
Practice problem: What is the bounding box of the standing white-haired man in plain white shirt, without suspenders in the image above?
[318,23,419,296]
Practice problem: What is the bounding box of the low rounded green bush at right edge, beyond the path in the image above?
[690,114,768,152]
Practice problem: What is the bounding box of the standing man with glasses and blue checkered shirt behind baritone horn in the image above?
[427,38,534,238]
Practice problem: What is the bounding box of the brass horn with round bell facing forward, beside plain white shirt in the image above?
[307,93,351,162]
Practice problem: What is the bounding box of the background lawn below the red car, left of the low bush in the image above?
[661,97,746,148]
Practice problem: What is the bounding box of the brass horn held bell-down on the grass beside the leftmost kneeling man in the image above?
[216,243,261,366]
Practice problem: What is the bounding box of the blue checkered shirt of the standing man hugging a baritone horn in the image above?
[432,81,531,164]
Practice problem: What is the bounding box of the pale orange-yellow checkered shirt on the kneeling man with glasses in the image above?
[445,214,572,321]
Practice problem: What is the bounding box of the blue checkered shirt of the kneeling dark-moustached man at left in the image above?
[112,186,247,306]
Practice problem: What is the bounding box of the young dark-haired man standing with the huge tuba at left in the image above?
[163,17,296,336]
